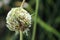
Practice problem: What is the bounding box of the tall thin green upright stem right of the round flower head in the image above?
[32,0,39,40]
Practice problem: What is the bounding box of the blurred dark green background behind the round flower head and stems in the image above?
[0,0,60,40]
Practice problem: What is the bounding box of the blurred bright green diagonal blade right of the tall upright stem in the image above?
[37,17,60,38]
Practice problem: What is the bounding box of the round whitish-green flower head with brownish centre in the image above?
[6,7,31,31]
